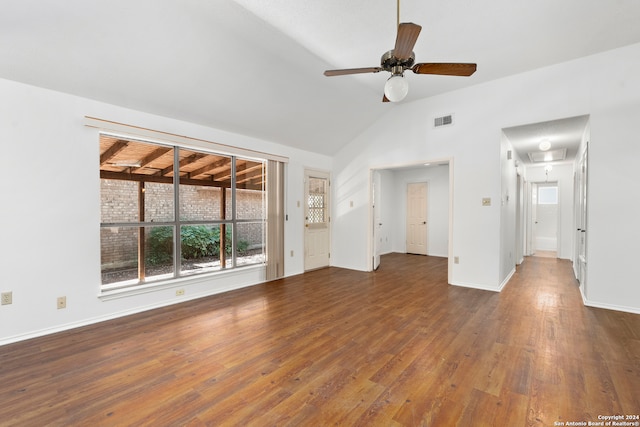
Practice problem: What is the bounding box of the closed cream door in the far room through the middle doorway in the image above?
[407,182,427,255]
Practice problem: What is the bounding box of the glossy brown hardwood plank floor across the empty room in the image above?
[0,254,640,426]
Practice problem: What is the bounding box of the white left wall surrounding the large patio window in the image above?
[0,76,332,344]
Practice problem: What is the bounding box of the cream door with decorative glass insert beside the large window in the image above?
[304,170,330,270]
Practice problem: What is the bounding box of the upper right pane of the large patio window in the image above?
[236,159,266,219]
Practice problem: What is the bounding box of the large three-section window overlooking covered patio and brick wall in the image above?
[100,134,267,290]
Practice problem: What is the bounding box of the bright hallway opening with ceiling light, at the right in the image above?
[501,115,590,287]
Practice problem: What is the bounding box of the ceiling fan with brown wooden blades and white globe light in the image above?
[324,0,476,102]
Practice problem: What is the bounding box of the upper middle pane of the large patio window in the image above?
[180,149,231,221]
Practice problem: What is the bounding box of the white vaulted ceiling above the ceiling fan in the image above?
[0,0,640,155]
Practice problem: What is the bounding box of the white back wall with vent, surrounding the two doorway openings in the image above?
[332,44,640,312]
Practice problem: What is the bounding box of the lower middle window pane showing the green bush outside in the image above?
[180,224,232,275]
